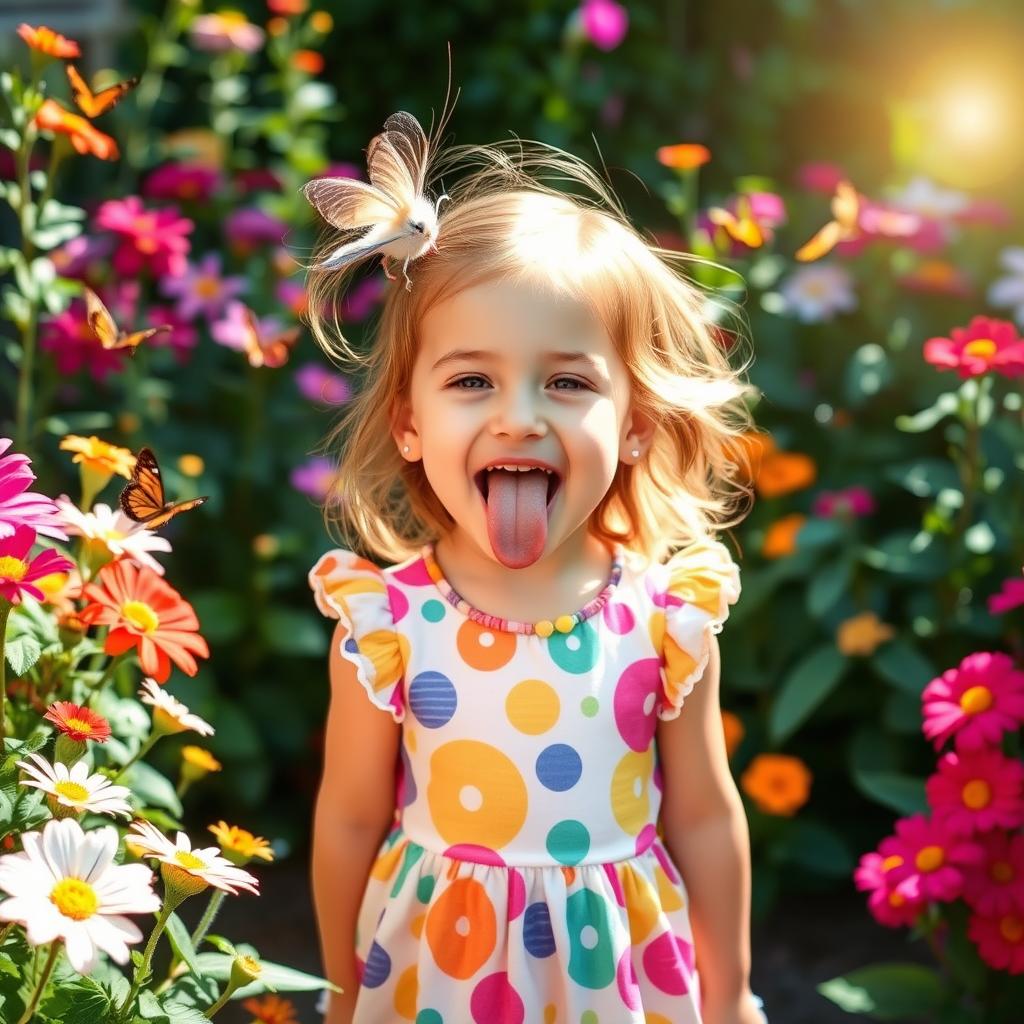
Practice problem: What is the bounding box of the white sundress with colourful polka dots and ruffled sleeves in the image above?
[309,539,740,1024]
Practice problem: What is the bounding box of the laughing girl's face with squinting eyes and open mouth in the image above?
[394,281,648,567]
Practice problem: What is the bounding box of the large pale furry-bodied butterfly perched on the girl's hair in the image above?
[302,54,459,290]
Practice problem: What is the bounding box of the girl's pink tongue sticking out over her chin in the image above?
[487,469,548,569]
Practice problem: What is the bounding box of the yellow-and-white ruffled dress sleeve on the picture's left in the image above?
[309,548,406,722]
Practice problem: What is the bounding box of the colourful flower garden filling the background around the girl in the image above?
[0,0,1024,1024]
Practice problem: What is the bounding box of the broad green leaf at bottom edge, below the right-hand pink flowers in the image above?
[817,964,947,1021]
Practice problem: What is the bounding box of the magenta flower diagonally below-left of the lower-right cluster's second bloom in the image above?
[879,814,985,901]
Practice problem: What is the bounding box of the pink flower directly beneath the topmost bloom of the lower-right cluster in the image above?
[925,749,1024,836]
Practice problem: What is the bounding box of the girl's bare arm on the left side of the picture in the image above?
[312,623,401,1024]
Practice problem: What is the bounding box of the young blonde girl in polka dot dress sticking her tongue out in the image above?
[309,116,765,1024]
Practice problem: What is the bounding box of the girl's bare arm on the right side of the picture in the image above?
[657,634,761,1024]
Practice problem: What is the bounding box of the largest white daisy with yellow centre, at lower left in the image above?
[0,818,160,974]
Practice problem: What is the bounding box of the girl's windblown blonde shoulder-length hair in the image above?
[307,139,757,562]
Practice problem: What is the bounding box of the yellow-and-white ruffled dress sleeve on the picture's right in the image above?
[657,538,740,721]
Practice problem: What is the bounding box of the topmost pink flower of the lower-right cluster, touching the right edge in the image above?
[921,651,1024,751]
